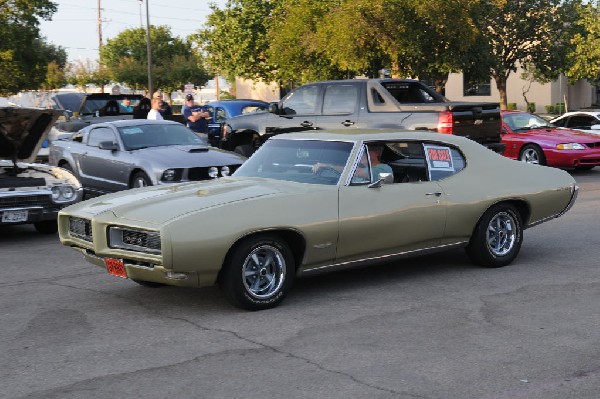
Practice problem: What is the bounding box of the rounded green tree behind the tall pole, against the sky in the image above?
[100,26,209,92]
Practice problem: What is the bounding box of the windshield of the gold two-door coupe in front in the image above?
[234,139,354,185]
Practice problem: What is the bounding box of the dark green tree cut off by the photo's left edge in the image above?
[0,0,67,95]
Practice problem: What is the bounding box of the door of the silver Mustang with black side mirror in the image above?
[79,126,129,192]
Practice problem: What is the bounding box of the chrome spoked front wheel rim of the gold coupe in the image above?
[242,245,285,299]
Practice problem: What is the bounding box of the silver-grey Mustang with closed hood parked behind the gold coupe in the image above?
[50,119,246,195]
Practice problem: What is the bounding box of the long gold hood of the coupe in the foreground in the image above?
[68,177,324,226]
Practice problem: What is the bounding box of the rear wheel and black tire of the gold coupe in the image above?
[466,204,523,267]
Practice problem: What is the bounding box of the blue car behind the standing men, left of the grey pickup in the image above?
[206,99,269,147]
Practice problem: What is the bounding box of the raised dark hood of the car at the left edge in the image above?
[0,107,62,163]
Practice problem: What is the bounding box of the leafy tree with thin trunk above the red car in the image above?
[473,0,576,109]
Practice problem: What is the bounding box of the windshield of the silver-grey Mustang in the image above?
[118,123,208,150]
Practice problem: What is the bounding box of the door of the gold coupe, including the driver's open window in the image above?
[336,143,447,263]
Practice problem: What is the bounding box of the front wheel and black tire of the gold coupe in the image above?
[219,234,295,310]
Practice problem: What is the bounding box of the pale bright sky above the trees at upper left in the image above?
[40,0,227,62]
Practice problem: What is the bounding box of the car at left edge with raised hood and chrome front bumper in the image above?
[0,107,82,233]
